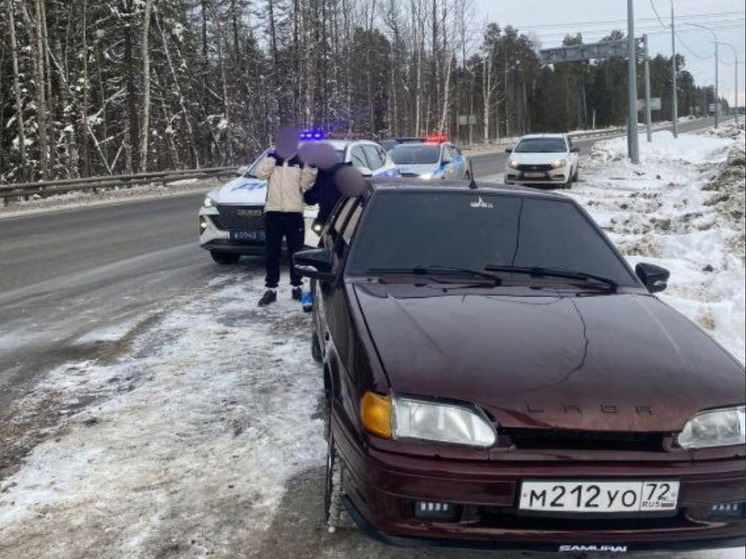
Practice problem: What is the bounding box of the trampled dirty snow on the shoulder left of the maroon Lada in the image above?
[0,281,325,559]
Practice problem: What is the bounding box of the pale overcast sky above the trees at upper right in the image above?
[475,0,746,106]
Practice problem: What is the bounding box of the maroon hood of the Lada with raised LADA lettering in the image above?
[355,284,746,432]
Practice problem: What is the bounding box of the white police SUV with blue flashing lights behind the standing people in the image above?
[199,137,400,264]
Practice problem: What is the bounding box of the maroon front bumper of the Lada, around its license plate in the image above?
[335,427,746,552]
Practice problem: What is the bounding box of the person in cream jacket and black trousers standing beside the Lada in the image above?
[257,136,318,307]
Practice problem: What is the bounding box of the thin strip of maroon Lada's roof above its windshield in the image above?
[368,177,573,202]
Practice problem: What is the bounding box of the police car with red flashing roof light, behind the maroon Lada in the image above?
[389,135,471,180]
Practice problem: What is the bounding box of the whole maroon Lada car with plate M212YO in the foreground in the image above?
[295,179,746,553]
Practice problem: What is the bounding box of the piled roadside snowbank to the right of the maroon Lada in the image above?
[571,125,746,363]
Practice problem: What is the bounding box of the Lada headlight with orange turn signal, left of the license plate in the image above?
[361,392,497,447]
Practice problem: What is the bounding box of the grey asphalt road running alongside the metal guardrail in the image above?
[0,115,724,412]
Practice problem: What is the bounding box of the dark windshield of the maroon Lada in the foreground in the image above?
[347,192,639,286]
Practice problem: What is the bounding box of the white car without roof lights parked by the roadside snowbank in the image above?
[504,134,580,188]
